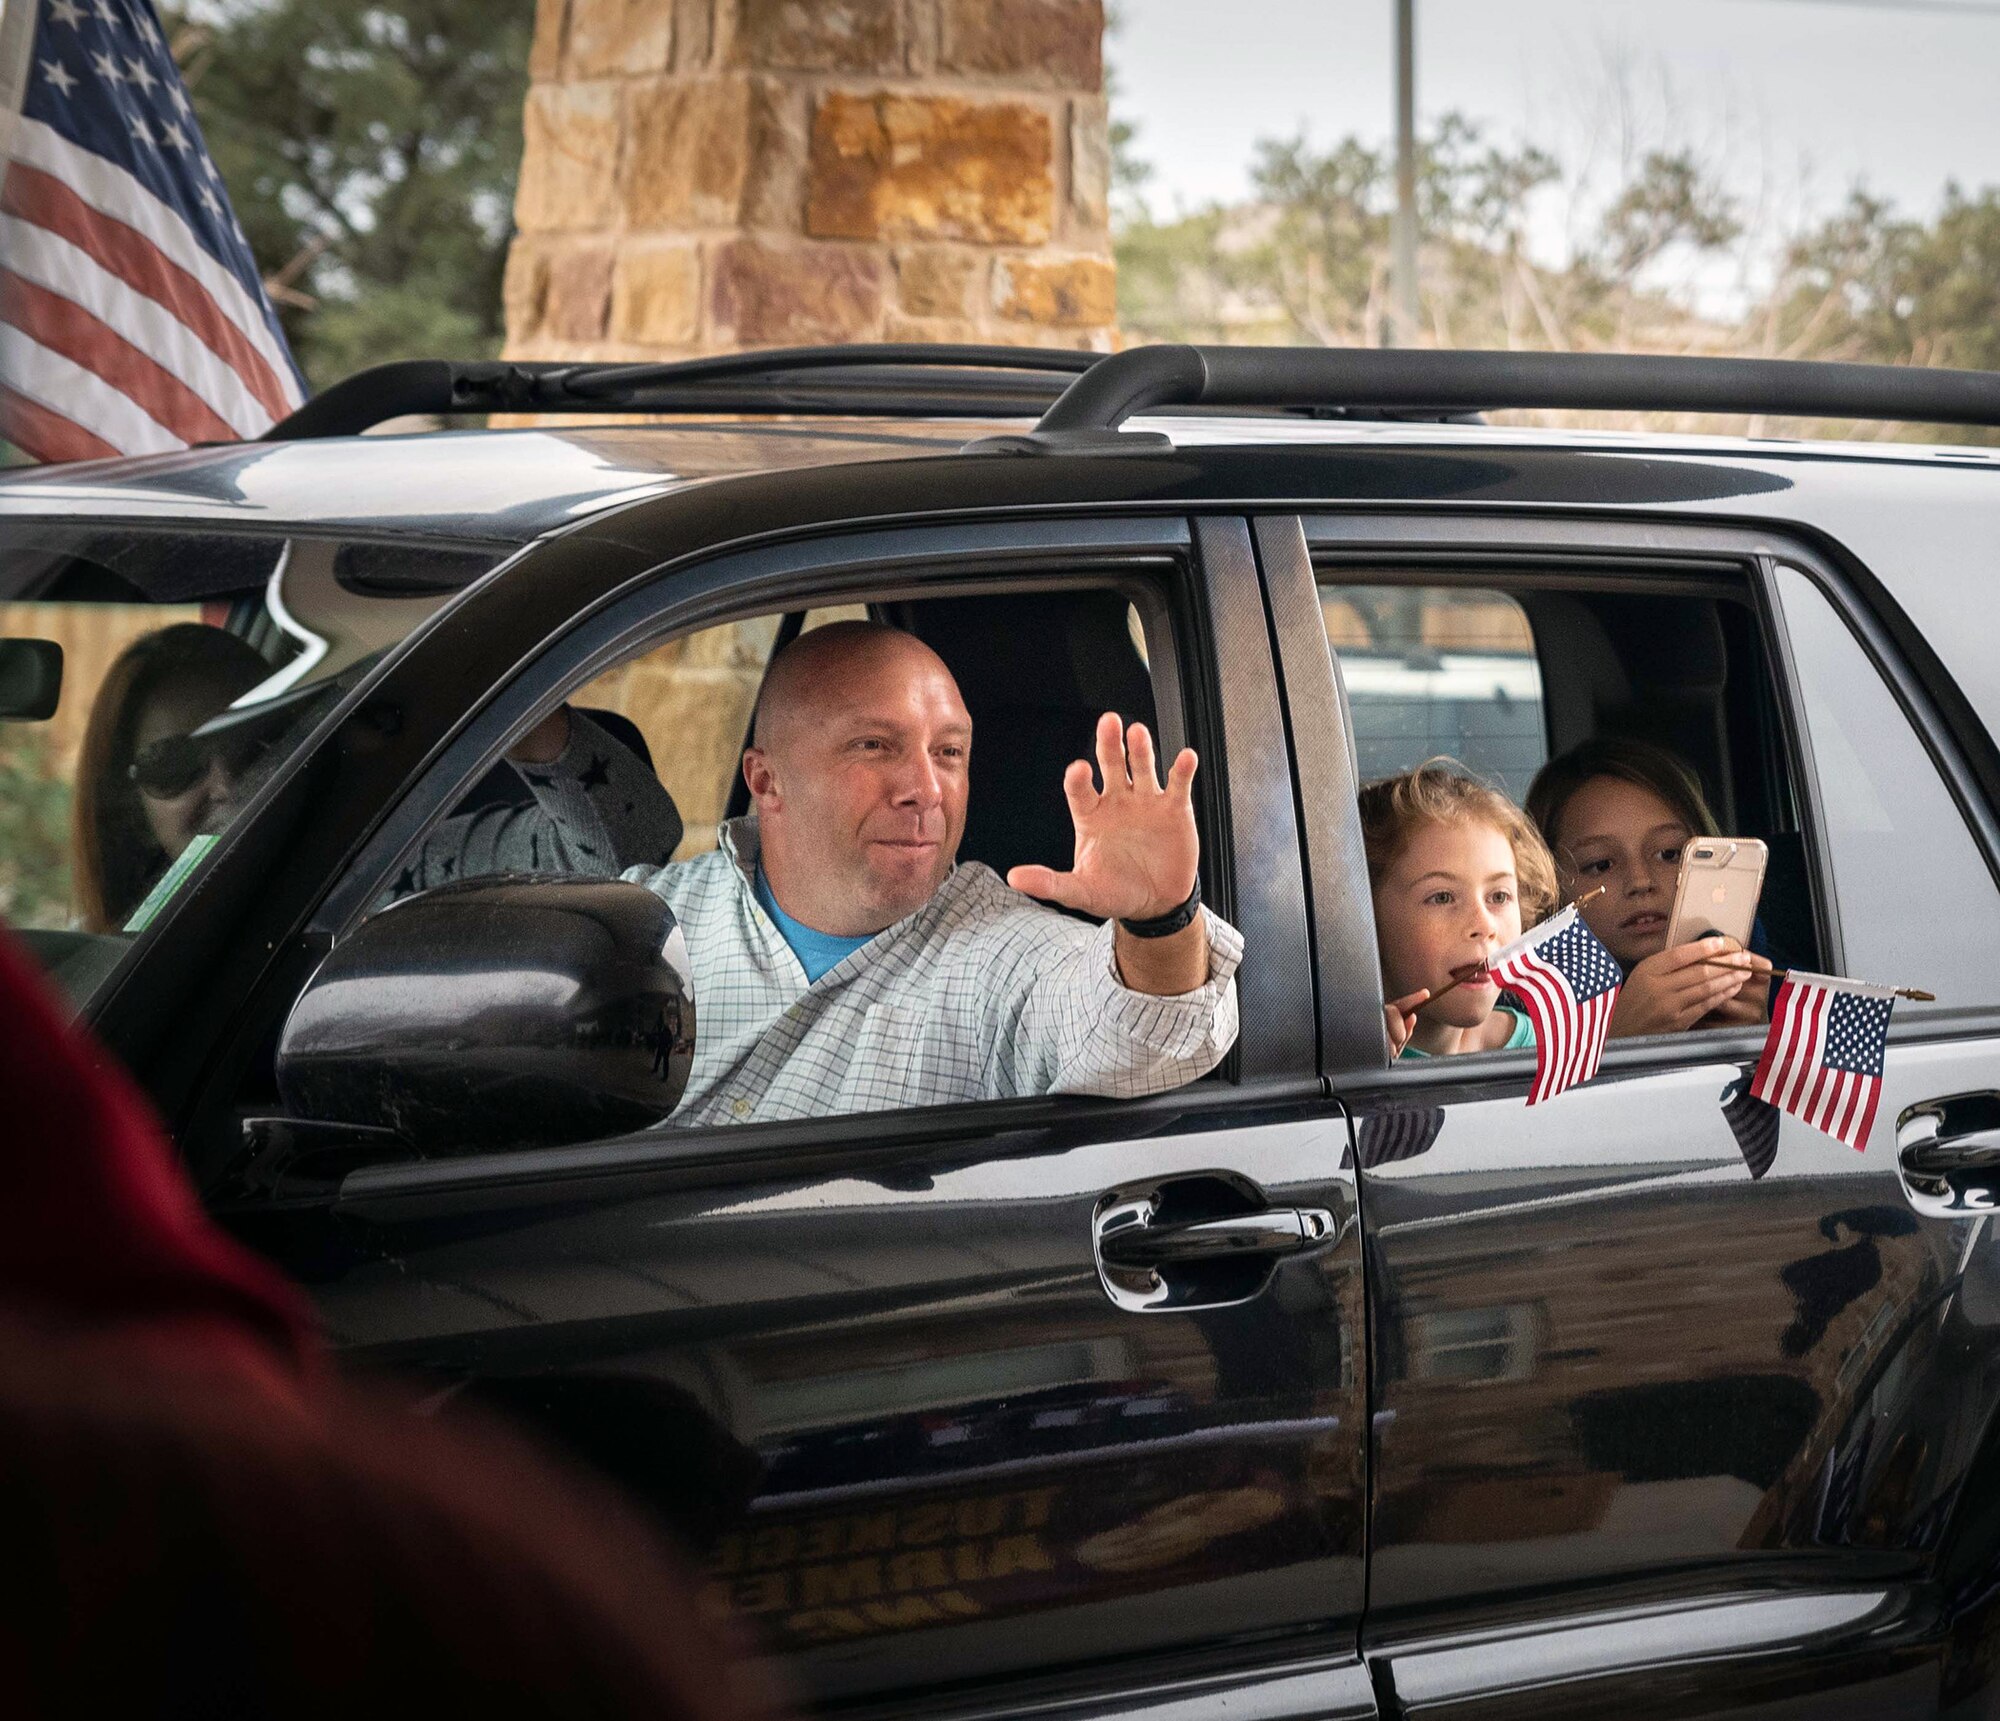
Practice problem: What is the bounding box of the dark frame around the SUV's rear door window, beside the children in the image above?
[1260,510,1968,1095]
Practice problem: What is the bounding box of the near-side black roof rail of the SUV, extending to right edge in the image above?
[970,346,2000,454]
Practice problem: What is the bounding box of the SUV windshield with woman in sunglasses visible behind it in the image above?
[0,522,488,1005]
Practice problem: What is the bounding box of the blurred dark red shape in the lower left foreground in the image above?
[0,933,766,1721]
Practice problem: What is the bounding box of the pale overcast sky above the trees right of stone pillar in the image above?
[1108,0,2000,286]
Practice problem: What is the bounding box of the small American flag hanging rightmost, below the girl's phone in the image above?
[1750,969,1896,1153]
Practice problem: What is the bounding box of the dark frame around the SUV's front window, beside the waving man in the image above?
[234,514,1322,1209]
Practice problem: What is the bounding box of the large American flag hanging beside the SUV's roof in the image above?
[0,0,306,460]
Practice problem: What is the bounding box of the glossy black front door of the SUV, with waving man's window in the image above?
[215,518,1374,1717]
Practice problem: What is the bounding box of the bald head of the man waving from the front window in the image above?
[744,622,972,937]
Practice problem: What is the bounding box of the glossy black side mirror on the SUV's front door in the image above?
[278,877,694,1159]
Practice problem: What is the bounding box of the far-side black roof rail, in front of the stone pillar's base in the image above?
[260,344,1100,442]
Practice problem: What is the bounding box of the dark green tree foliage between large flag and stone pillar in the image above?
[162,0,534,386]
